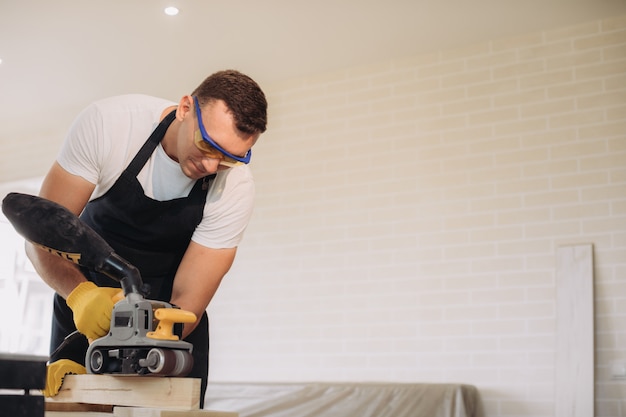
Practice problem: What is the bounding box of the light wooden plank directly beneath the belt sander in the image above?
[46,374,200,410]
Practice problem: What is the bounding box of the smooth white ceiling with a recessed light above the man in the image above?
[0,0,626,158]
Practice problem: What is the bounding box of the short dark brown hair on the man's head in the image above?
[191,70,267,134]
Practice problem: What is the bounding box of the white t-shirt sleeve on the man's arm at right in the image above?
[191,166,255,249]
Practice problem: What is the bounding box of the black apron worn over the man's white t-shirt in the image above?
[50,111,215,407]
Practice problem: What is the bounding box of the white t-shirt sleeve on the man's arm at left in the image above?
[57,104,105,184]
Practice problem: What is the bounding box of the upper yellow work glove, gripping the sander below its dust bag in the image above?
[66,281,121,340]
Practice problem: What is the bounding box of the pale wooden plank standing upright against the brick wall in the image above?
[555,244,594,417]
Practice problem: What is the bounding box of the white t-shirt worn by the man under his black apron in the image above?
[57,94,254,249]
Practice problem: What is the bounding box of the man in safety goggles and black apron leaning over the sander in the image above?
[27,70,267,404]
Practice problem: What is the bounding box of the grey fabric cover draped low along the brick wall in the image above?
[205,382,484,417]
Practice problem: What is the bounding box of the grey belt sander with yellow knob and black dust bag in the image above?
[2,193,196,376]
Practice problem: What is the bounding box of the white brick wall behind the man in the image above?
[210,16,626,417]
